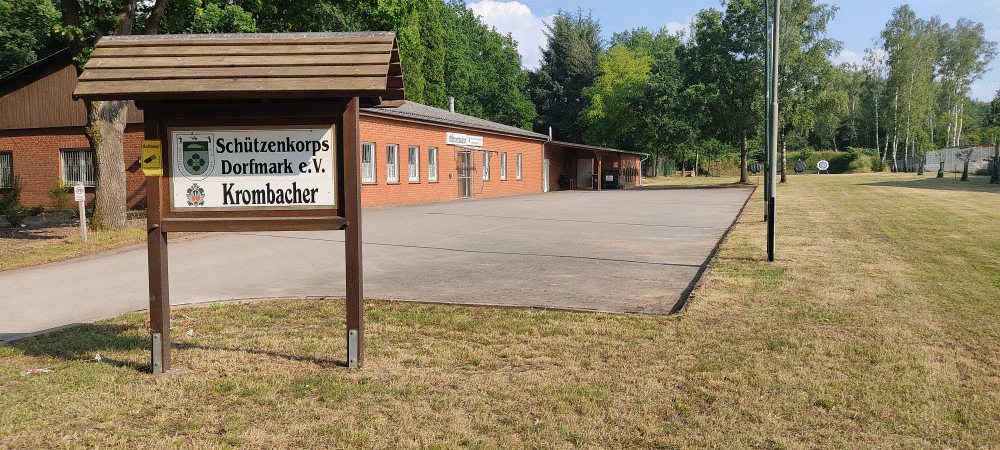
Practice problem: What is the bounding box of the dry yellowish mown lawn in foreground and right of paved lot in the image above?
[0,174,1000,449]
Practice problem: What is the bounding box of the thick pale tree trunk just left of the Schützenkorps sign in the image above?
[87,100,128,230]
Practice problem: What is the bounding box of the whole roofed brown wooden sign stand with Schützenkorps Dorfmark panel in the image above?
[75,32,403,374]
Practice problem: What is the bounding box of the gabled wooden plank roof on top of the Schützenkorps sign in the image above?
[73,32,403,100]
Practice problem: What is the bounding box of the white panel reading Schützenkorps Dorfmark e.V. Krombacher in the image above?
[170,127,337,210]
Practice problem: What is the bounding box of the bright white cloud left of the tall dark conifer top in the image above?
[468,0,552,69]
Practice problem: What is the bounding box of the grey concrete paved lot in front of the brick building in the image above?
[0,189,750,340]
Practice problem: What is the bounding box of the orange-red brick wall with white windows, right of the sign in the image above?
[359,115,542,207]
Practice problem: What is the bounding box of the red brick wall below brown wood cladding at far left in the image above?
[0,124,146,207]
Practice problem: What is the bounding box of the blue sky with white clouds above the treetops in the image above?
[466,0,1000,101]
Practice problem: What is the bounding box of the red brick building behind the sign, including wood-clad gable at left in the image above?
[0,52,645,211]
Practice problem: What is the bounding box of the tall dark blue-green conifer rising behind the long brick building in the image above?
[529,11,603,142]
